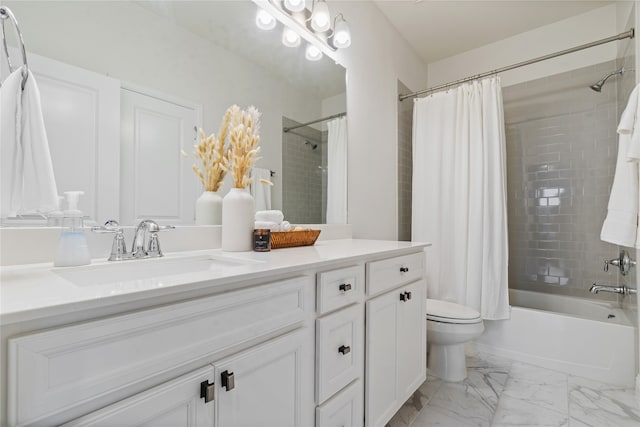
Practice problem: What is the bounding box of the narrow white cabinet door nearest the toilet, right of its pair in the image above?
[397,279,427,402]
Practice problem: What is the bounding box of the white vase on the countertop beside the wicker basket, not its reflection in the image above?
[222,188,255,252]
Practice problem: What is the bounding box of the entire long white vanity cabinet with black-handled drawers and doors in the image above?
[0,240,426,427]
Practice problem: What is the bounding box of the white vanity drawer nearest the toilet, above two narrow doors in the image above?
[367,252,426,296]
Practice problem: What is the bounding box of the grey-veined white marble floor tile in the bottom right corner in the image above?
[569,376,640,427]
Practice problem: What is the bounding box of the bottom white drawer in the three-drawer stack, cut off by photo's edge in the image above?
[316,380,364,427]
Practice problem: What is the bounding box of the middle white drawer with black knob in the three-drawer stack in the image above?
[316,305,364,403]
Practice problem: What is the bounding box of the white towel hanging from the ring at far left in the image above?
[0,67,58,217]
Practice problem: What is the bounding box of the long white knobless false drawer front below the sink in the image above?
[8,276,314,425]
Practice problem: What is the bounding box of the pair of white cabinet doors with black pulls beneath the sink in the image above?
[64,328,313,427]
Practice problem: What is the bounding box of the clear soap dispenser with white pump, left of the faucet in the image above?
[53,191,91,267]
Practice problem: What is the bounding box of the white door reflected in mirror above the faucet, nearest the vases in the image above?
[120,88,202,224]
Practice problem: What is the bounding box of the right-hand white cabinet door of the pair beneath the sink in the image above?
[215,328,314,427]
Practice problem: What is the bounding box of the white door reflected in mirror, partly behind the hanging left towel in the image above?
[2,50,120,222]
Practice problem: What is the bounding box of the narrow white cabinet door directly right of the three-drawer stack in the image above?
[365,290,400,427]
